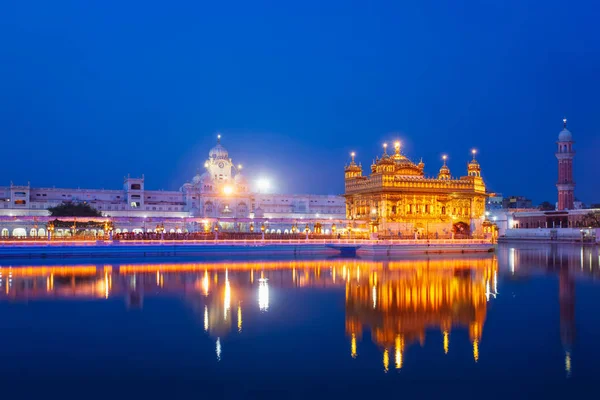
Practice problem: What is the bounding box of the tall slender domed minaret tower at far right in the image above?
[556,118,575,211]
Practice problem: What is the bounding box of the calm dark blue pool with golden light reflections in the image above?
[0,245,600,398]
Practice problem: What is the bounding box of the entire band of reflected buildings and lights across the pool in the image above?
[0,246,600,376]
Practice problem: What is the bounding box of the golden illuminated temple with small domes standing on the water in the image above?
[344,142,486,238]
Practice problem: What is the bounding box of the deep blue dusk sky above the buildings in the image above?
[0,0,600,202]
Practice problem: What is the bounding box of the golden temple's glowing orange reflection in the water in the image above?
[346,257,498,371]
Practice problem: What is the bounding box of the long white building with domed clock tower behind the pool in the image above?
[0,135,345,236]
